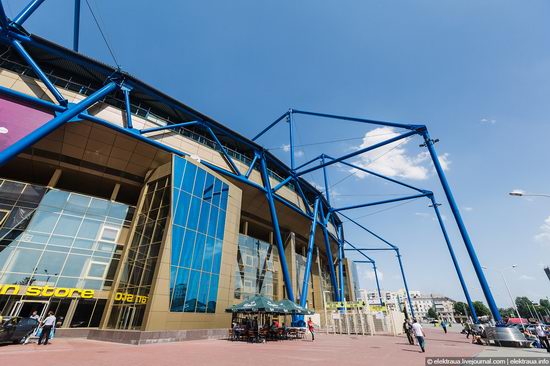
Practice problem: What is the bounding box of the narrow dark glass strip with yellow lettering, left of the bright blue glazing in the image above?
[108,177,171,329]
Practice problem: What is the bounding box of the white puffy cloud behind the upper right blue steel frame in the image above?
[352,127,451,180]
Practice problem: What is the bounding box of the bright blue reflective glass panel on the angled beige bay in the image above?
[170,157,229,313]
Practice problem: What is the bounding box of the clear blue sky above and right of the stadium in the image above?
[4,0,550,306]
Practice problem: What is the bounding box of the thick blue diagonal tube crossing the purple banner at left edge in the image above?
[0,82,116,166]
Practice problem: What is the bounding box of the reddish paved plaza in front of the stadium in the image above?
[0,328,536,366]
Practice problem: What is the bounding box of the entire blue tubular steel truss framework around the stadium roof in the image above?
[0,0,501,322]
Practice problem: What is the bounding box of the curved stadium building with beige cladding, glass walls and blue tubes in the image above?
[0,9,355,344]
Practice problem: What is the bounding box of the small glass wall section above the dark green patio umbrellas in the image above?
[233,234,282,300]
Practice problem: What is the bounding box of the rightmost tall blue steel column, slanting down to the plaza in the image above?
[423,130,502,323]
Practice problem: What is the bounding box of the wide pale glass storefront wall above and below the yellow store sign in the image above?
[0,179,134,328]
